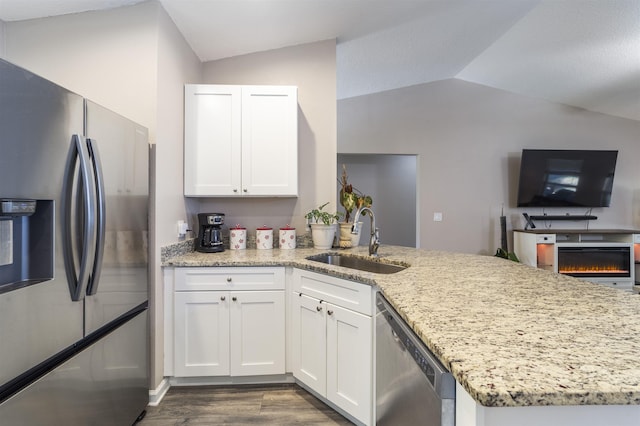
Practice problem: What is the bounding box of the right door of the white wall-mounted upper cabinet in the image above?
[242,86,298,196]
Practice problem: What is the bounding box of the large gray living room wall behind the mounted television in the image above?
[338,79,640,254]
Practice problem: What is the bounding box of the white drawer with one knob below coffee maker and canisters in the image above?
[175,267,284,291]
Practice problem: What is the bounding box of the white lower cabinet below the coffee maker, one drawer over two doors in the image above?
[173,268,285,377]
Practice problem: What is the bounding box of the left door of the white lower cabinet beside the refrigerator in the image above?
[174,291,229,377]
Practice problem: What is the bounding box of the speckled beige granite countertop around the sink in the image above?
[162,241,640,407]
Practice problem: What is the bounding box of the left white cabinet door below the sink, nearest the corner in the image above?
[291,293,327,396]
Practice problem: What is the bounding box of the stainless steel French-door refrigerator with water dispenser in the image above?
[0,60,149,426]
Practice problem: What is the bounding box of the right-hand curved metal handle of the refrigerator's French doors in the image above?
[87,138,107,296]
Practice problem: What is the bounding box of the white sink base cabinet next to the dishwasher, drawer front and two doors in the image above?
[291,269,374,425]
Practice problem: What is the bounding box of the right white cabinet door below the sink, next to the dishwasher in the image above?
[326,304,373,424]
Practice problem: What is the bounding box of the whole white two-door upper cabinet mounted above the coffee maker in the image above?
[184,84,298,197]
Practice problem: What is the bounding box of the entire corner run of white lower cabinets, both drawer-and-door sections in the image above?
[165,267,375,425]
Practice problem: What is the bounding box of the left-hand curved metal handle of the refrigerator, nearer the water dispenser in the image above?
[62,135,97,301]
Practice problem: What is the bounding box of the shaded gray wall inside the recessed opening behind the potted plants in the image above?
[337,154,418,247]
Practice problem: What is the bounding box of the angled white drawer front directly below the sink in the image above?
[293,269,374,315]
